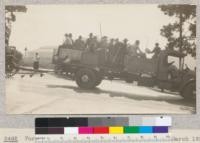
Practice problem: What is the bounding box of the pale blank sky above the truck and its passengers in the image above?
[10,4,195,68]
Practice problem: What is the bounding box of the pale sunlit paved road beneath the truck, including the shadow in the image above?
[6,74,195,114]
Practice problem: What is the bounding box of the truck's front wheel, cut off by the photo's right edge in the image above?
[181,83,196,99]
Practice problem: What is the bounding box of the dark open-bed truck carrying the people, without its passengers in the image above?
[53,46,196,99]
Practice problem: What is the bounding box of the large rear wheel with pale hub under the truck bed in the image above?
[75,69,97,89]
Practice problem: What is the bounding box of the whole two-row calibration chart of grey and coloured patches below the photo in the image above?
[35,117,171,135]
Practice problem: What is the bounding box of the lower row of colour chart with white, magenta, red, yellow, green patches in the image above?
[35,126,168,135]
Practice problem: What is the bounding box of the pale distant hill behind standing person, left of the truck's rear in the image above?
[22,46,57,69]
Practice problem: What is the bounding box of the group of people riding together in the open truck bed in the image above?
[63,33,161,66]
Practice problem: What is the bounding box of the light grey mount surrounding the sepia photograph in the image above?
[0,0,200,129]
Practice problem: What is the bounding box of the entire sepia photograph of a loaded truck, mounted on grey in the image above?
[5,4,197,115]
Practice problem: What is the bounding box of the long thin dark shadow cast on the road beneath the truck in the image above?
[47,84,196,110]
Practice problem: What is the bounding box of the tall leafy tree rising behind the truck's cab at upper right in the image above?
[158,5,196,57]
